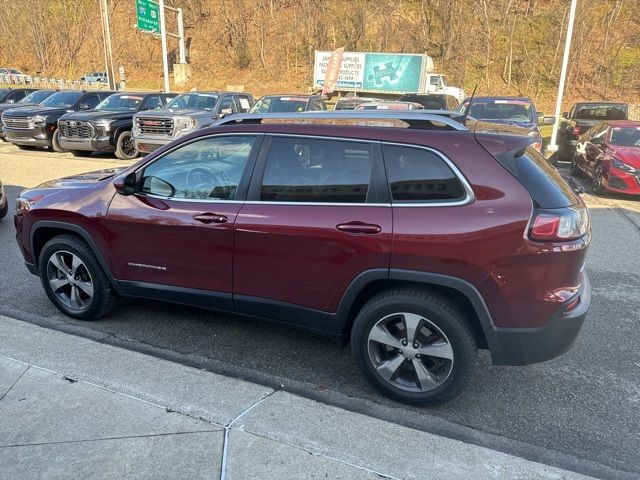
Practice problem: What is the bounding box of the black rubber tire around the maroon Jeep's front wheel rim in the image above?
[38,235,116,320]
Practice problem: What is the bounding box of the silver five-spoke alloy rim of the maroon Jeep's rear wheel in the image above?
[367,312,454,392]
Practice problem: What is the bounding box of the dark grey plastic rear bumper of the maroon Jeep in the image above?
[488,272,591,365]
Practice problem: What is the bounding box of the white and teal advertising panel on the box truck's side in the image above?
[313,52,428,92]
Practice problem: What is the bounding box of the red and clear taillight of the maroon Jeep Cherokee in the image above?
[529,205,589,242]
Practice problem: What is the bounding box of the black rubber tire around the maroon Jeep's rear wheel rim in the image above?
[351,288,477,406]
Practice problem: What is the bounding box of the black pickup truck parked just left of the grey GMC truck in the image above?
[58,92,178,160]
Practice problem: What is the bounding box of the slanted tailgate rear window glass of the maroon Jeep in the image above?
[496,146,578,208]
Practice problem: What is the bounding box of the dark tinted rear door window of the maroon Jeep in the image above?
[260,137,373,203]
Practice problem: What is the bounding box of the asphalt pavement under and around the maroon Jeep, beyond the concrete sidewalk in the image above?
[0,144,640,478]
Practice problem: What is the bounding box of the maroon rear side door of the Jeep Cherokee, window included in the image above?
[233,135,392,330]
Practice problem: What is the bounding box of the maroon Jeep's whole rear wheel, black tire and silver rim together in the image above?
[351,288,477,405]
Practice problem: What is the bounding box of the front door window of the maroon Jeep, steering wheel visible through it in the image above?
[141,135,256,200]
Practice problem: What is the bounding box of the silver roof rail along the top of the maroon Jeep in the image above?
[212,110,469,131]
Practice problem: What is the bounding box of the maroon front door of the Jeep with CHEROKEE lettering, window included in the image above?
[106,134,262,296]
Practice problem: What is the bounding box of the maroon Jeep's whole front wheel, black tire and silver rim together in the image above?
[39,235,115,320]
